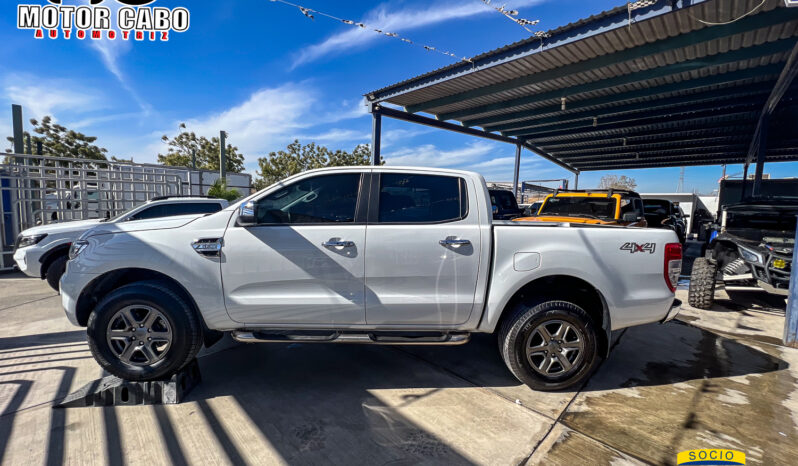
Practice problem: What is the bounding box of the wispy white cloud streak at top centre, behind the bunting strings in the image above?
[292,0,543,68]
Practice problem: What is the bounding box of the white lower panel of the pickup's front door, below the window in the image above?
[222,225,366,324]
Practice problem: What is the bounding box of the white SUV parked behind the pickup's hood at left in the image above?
[14,196,228,291]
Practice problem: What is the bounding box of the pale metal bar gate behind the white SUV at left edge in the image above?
[0,154,251,270]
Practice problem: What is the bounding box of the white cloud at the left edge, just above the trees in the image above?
[3,74,104,121]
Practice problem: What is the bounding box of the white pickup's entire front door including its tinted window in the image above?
[221,171,368,326]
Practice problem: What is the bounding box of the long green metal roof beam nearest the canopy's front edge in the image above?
[406,8,798,113]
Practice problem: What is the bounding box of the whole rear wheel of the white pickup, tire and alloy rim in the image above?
[499,301,599,391]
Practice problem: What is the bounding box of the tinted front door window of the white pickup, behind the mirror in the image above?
[257,173,360,224]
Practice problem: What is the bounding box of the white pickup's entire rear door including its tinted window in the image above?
[366,174,481,327]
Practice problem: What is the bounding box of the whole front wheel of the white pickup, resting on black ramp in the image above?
[87,282,202,381]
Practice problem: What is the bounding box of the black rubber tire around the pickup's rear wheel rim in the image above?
[499,301,600,391]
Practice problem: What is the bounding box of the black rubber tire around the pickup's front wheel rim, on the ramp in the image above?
[86,281,202,381]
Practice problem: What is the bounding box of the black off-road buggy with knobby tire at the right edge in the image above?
[688,197,798,309]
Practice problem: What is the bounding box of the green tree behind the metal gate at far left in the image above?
[6,116,108,160]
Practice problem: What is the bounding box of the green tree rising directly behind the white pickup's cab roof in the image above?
[254,140,371,189]
